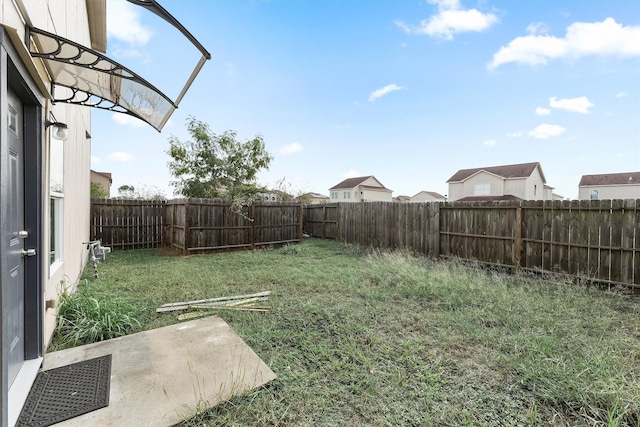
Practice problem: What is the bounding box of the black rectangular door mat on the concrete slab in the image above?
[16,354,111,427]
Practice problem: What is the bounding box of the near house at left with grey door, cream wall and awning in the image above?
[0,0,210,427]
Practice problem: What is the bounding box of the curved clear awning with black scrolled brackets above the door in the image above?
[26,0,211,131]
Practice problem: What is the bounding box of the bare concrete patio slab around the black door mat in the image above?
[43,316,276,427]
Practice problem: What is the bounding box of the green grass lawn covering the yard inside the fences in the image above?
[51,239,640,426]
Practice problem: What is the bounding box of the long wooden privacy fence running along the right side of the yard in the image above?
[304,199,640,288]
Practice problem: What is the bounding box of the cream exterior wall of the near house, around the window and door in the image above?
[0,0,91,346]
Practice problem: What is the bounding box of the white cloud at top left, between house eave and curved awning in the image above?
[107,0,153,46]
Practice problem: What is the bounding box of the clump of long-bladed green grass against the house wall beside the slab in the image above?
[55,287,141,350]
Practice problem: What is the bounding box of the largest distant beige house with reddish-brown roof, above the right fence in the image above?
[447,162,560,202]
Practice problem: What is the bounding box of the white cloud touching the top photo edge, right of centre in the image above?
[396,0,499,40]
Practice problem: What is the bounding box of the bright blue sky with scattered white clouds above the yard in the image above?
[92,0,640,198]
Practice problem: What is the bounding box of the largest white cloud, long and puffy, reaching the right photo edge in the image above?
[488,18,640,69]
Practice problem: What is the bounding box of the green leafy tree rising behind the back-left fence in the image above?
[167,116,273,204]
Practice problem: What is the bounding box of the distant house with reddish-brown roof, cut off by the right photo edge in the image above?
[578,172,640,200]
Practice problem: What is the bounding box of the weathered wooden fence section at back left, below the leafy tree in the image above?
[90,199,303,254]
